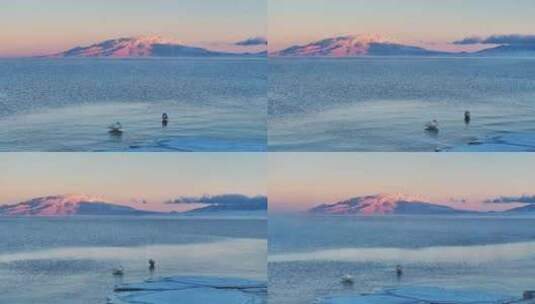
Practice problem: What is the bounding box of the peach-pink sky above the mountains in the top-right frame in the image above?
[268,0,535,51]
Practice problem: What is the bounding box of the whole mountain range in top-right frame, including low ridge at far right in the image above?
[270,35,535,57]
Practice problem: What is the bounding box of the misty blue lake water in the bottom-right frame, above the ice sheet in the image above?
[269,216,535,304]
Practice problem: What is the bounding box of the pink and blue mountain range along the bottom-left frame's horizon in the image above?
[0,195,267,216]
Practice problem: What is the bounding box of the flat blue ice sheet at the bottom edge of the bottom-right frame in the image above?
[318,287,519,304]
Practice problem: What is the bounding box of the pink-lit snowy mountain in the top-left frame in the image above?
[47,36,260,58]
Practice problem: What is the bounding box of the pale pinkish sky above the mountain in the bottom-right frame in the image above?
[268,153,535,212]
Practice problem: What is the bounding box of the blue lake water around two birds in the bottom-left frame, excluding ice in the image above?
[0,217,267,304]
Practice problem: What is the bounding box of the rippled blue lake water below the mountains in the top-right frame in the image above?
[268,57,535,152]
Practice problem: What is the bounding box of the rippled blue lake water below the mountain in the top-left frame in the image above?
[0,58,267,151]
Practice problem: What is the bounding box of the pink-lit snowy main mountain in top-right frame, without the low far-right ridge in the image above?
[271,35,449,57]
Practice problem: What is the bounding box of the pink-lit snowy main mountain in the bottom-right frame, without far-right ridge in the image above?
[309,194,467,215]
